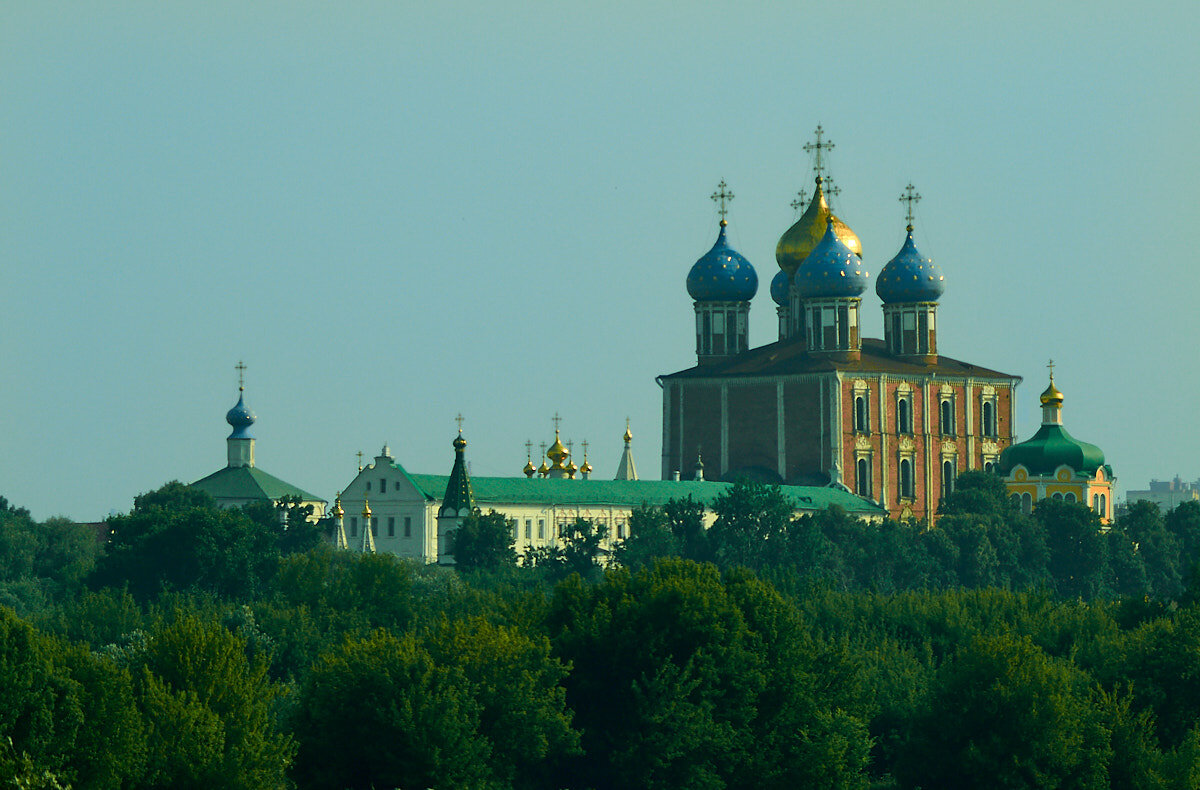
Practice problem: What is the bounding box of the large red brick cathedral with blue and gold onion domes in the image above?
[658,153,1020,520]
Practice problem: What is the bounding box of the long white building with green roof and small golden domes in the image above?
[334,429,887,562]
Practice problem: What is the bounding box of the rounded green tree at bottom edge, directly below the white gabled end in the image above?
[294,630,493,789]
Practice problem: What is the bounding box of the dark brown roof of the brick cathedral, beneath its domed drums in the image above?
[661,337,1020,381]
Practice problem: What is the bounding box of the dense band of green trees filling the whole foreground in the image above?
[0,473,1200,788]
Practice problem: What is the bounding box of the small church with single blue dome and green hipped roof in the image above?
[192,387,325,519]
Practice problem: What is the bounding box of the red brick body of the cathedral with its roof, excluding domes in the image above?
[661,341,1019,521]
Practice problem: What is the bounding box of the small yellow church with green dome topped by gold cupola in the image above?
[1000,371,1116,523]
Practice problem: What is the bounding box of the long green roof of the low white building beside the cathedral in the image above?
[407,473,887,516]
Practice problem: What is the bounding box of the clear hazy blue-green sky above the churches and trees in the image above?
[0,0,1200,520]
